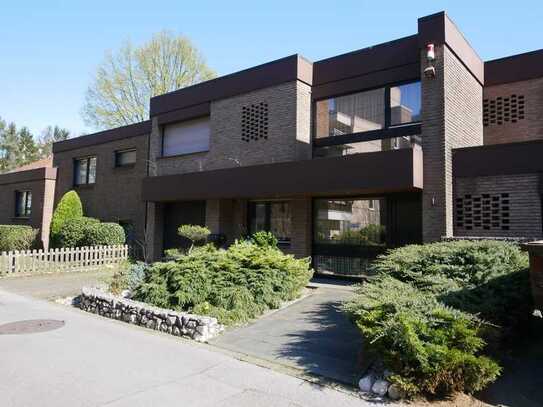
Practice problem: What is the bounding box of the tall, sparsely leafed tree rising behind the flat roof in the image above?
[82,31,215,129]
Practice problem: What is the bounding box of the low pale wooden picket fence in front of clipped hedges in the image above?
[0,245,128,276]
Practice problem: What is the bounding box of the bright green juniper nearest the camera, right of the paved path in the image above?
[346,276,500,396]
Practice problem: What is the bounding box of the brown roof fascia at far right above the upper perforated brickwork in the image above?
[485,49,543,86]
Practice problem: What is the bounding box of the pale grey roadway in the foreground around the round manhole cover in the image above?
[0,289,376,407]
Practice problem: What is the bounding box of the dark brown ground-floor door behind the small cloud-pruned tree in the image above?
[164,201,206,250]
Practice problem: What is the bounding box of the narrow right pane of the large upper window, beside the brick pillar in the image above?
[390,82,421,126]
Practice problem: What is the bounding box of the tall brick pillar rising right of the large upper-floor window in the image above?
[419,13,483,242]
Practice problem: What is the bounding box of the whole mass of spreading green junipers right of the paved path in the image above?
[345,241,531,396]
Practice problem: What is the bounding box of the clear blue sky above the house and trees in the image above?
[0,0,543,137]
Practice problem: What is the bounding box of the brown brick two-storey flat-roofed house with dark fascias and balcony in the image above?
[3,13,543,274]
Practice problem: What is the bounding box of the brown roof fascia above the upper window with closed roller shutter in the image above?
[150,54,313,117]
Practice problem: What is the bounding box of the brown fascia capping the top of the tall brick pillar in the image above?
[418,11,485,85]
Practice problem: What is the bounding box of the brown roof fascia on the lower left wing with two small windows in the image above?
[53,120,151,154]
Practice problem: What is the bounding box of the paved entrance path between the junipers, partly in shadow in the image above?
[211,280,371,385]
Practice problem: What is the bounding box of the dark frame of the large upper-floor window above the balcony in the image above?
[311,78,422,147]
